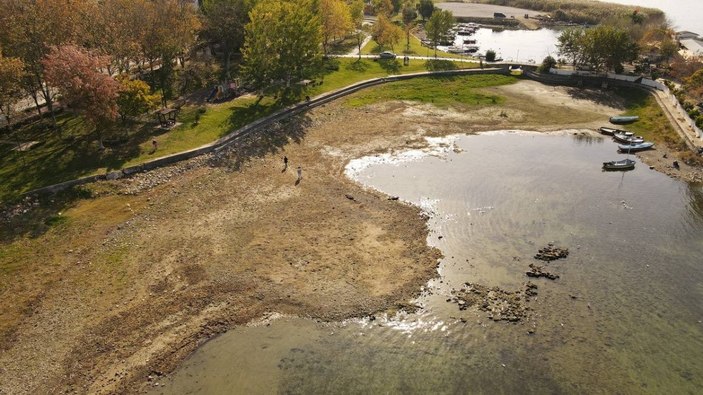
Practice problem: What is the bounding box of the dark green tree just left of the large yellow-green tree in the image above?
[202,0,251,79]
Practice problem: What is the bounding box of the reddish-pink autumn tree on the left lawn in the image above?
[43,45,120,147]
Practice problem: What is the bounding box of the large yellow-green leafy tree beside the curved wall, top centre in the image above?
[242,0,322,98]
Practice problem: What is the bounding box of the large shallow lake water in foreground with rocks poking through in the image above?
[154,132,703,394]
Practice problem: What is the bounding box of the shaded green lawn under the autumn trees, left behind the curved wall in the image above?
[0,97,279,201]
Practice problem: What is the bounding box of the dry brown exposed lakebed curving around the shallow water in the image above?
[0,81,700,394]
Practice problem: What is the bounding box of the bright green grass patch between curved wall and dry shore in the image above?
[346,74,517,107]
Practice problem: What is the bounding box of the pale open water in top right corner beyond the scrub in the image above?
[608,0,703,34]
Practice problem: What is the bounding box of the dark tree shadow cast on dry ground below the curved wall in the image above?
[212,114,311,171]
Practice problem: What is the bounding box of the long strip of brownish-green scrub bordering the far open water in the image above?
[480,0,665,25]
